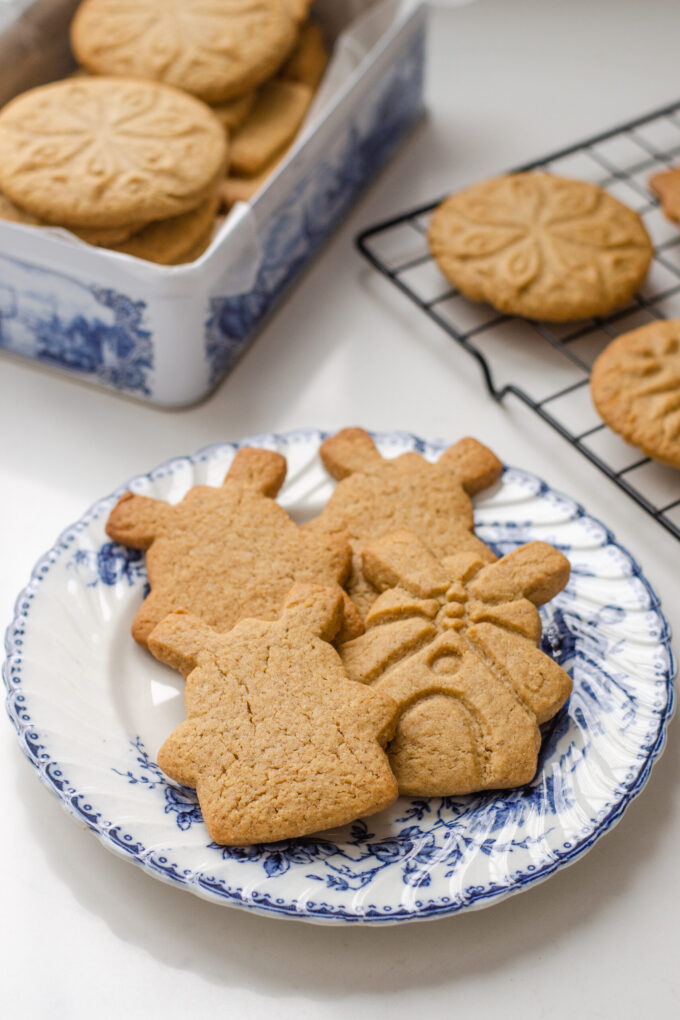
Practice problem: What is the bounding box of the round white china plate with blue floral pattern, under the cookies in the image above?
[4,431,673,924]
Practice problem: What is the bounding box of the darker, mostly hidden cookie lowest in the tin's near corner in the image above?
[108,194,219,265]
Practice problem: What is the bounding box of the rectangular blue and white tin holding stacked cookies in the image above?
[0,0,425,407]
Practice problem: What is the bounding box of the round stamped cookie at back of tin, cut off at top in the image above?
[70,0,297,103]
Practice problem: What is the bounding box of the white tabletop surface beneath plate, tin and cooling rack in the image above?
[0,0,680,1020]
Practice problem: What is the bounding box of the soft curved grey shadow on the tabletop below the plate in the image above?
[11,709,680,1000]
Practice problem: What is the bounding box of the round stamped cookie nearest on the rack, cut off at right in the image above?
[590,319,680,467]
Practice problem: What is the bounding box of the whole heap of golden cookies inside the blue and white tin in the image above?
[0,0,327,264]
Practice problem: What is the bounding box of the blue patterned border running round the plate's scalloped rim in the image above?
[2,429,675,923]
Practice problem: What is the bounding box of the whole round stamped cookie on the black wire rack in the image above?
[428,173,652,322]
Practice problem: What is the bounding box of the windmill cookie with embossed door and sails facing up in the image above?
[338,531,571,797]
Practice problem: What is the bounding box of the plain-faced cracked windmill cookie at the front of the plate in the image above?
[149,584,398,846]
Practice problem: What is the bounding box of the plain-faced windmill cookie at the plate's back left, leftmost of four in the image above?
[106,448,361,646]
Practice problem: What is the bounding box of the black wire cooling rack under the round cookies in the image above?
[357,102,680,539]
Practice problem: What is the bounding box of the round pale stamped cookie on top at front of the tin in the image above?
[0,78,227,227]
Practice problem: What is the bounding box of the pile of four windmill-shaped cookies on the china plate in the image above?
[107,428,571,845]
